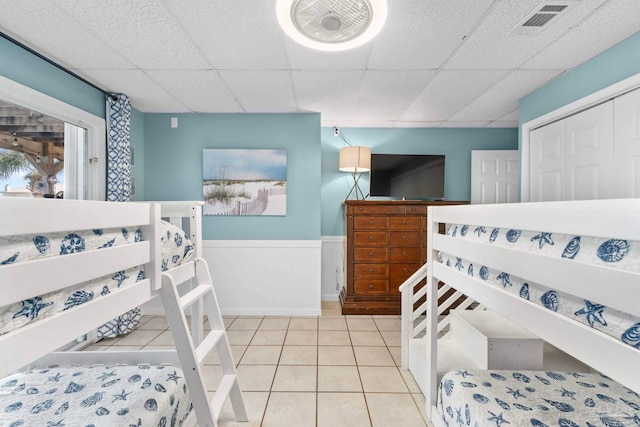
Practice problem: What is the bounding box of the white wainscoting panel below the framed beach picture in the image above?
[202,240,322,316]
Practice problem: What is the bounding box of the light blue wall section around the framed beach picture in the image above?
[144,113,321,240]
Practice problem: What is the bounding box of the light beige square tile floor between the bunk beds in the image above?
[89,302,431,427]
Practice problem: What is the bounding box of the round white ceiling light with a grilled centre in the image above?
[276,0,387,51]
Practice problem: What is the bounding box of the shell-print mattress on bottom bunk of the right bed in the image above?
[438,371,640,427]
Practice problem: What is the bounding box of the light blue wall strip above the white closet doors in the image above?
[518,32,640,125]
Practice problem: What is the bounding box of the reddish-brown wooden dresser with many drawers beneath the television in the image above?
[340,200,468,314]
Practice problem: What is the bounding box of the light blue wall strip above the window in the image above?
[0,37,106,118]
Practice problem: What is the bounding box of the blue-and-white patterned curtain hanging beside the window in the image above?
[97,95,140,340]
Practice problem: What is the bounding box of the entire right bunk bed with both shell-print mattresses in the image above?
[423,199,640,426]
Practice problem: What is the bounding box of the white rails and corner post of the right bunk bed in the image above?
[424,199,640,423]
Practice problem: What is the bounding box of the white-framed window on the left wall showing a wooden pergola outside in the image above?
[0,76,106,200]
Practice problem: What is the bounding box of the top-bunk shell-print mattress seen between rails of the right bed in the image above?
[439,224,640,348]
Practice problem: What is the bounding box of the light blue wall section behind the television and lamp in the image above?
[322,128,518,236]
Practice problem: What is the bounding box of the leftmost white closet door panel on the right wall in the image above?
[529,120,566,202]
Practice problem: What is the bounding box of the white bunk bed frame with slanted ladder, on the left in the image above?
[0,198,247,426]
